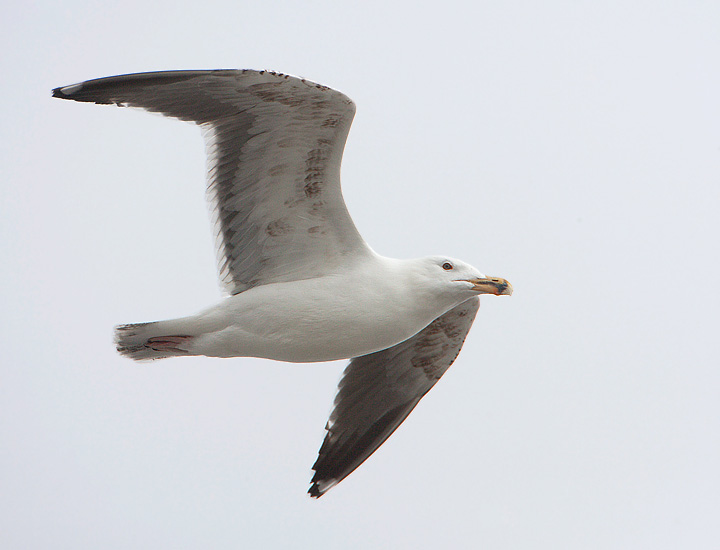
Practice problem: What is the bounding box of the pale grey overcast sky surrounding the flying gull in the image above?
[0,0,720,550]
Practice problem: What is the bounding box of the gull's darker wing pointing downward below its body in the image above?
[308,298,480,497]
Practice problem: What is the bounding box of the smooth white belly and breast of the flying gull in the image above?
[159,258,476,362]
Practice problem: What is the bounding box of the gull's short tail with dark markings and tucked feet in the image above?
[115,321,195,361]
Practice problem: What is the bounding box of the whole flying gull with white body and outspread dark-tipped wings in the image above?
[53,70,512,498]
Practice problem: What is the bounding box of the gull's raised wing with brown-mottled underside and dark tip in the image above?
[53,70,369,294]
